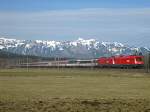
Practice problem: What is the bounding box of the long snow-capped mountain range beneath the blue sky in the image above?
[0,38,149,58]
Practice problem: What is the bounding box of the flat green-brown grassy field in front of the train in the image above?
[0,69,150,112]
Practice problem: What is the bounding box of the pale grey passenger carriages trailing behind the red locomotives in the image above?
[15,59,97,68]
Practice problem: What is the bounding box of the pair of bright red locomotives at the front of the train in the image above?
[98,55,144,67]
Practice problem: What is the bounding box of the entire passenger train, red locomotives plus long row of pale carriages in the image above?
[14,55,144,68]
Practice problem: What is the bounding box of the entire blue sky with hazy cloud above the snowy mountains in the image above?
[0,0,150,47]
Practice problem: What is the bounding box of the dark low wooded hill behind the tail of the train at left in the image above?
[0,50,65,68]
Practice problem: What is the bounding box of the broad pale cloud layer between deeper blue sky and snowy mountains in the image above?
[0,8,150,46]
